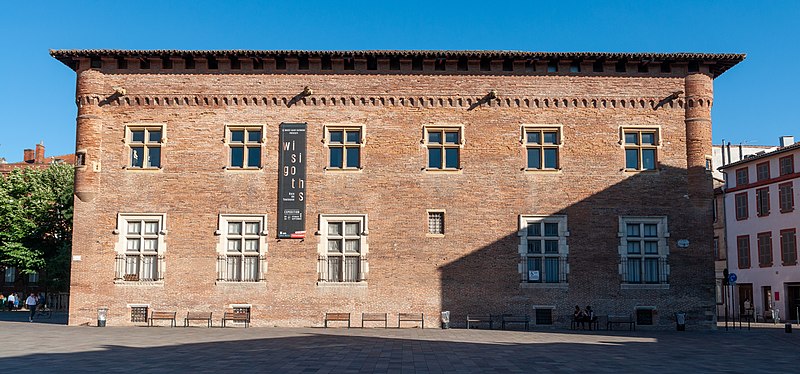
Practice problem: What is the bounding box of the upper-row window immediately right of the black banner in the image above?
[325,126,364,170]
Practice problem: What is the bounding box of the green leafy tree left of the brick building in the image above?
[0,164,74,289]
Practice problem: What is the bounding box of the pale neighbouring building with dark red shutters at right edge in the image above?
[721,137,800,320]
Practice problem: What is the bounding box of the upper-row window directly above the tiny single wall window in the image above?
[425,127,464,170]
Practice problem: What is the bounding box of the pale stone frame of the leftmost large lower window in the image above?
[113,213,167,285]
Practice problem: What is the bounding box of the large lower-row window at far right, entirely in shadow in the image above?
[620,217,669,284]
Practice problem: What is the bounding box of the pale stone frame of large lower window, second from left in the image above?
[214,214,269,284]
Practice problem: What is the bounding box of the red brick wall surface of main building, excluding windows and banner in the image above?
[70,66,714,326]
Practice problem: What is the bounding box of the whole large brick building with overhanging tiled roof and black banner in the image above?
[51,50,744,326]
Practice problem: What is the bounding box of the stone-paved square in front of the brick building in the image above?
[0,321,800,374]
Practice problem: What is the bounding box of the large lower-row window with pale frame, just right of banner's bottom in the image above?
[317,214,369,283]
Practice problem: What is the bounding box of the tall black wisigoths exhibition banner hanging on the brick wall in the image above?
[278,123,306,239]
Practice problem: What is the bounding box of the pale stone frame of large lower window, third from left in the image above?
[317,214,369,286]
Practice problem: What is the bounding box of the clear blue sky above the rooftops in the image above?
[0,0,800,162]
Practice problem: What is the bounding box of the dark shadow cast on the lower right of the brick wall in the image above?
[439,166,716,330]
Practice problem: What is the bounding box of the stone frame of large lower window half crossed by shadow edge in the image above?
[517,214,570,288]
